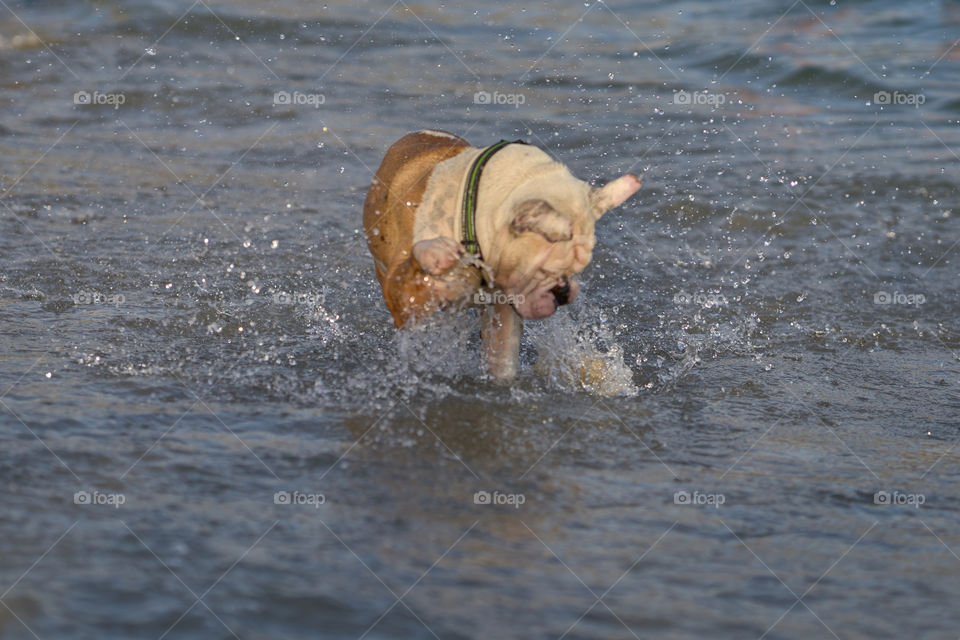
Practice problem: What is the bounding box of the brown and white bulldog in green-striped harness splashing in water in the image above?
[363,130,640,381]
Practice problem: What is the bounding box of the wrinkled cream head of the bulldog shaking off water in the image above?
[485,163,641,319]
